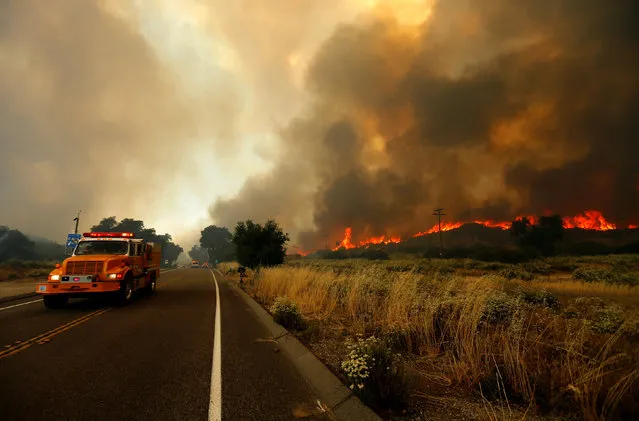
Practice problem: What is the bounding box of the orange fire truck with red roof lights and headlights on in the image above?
[36,232,162,308]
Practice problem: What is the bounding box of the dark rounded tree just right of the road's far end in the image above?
[232,220,289,269]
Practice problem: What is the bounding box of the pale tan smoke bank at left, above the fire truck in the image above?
[0,0,235,241]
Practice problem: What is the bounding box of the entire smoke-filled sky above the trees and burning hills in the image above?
[0,0,639,249]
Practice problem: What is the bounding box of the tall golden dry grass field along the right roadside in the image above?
[238,262,639,421]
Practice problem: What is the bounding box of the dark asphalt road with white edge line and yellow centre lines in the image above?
[0,269,328,421]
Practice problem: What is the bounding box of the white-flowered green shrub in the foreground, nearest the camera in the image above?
[342,335,408,409]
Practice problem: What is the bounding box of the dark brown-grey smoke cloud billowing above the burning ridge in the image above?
[212,0,639,248]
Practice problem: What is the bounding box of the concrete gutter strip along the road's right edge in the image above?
[225,271,382,421]
